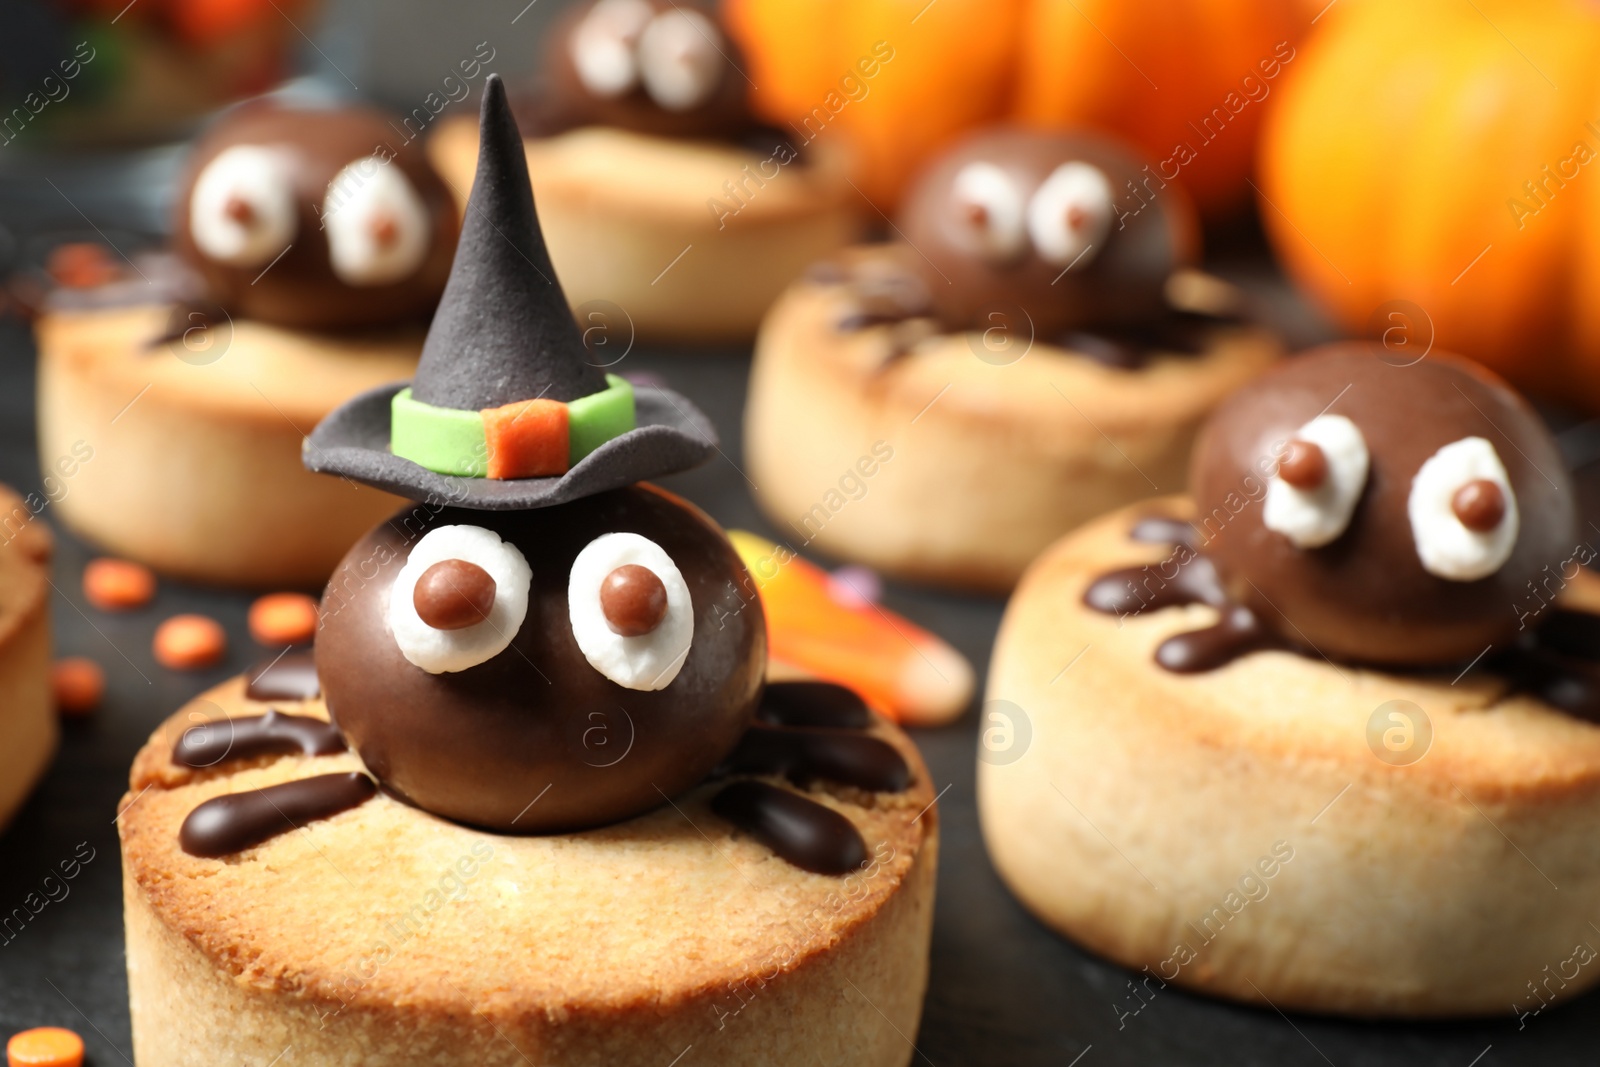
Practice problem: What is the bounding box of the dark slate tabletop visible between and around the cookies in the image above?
[0,287,1600,1067]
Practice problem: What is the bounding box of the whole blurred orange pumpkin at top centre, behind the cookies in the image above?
[725,0,1315,216]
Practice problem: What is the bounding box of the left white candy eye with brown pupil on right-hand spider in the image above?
[1261,414,1371,549]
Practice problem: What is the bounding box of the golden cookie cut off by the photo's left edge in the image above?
[0,485,58,830]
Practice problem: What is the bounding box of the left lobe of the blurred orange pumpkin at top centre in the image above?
[723,0,1024,206]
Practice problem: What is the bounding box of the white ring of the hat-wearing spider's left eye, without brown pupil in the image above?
[389,526,533,675]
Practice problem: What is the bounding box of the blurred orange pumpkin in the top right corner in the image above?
[1261,0,1600,410]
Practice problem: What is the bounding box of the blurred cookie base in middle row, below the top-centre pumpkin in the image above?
[744,259,1282,590]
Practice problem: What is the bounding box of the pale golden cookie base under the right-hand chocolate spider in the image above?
[978,498,1600,1016]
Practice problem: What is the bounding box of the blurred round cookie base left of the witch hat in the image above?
[37,306,422,587]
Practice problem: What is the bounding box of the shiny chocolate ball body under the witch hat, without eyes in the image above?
[317,486,766,833]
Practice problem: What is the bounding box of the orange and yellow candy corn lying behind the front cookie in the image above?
[728,530,974,726]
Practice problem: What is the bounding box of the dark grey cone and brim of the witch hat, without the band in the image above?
[301,75,717,510]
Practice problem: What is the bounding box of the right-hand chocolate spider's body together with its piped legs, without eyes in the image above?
[1083,344,1600,684]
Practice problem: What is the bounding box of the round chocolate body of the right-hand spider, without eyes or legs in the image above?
[1190,344,1578,665]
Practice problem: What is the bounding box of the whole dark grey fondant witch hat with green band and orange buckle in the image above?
[301,75,717,510]
